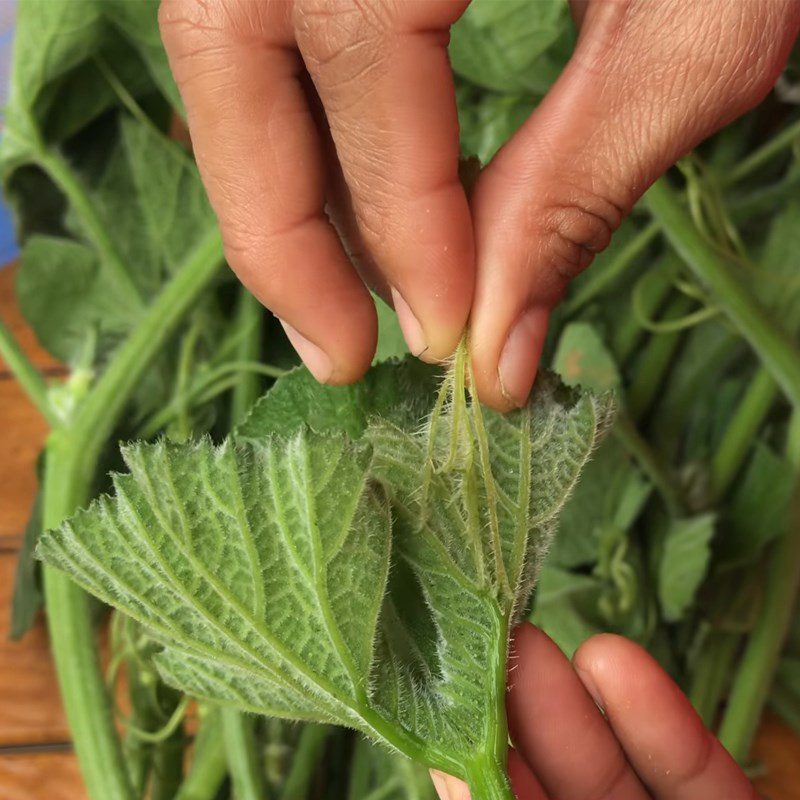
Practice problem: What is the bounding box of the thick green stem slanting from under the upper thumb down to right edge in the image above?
[647,178,800,407]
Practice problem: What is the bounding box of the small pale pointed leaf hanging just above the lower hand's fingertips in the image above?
[658,514,715,622]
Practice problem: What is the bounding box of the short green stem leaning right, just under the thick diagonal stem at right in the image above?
[711,367,778,498]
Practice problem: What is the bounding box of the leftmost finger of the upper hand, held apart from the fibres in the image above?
[159,0,377,383]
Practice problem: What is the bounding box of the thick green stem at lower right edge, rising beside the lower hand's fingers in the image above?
[719,410,800,762]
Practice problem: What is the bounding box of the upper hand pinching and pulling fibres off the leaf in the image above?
[160,0,800,409]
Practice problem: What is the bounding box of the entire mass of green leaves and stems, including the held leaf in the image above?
[0,0,800,800]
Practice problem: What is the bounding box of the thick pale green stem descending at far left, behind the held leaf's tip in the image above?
[42,440,135,800]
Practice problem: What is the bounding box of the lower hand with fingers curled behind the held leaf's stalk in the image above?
[434,624,758,800]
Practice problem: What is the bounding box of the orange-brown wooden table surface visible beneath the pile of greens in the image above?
[0,267,800,800]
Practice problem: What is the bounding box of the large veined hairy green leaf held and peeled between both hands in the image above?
[39,353,610,788]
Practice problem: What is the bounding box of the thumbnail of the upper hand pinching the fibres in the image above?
[497,306,550,408]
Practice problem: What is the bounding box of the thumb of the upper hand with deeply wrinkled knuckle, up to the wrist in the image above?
[471,0,800,410]
